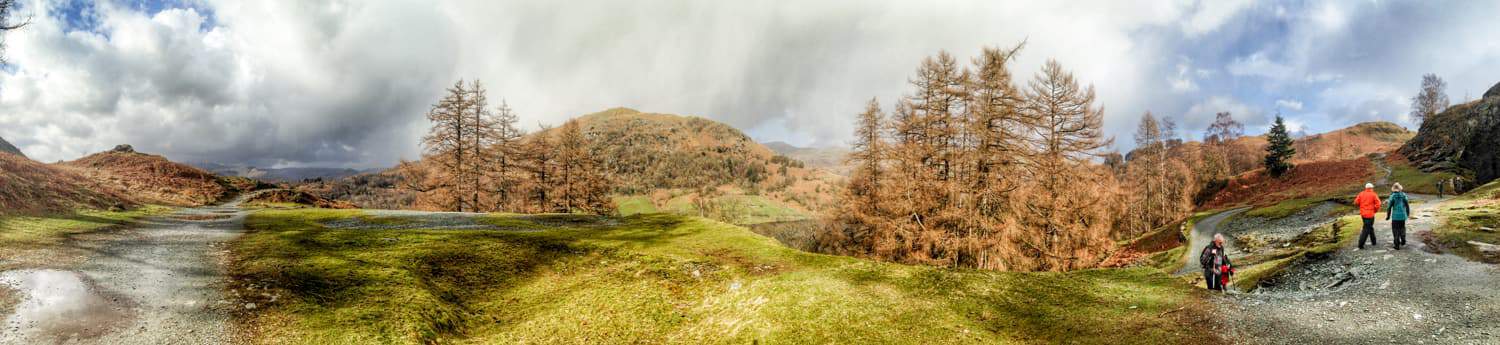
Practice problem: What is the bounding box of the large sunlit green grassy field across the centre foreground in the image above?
[231,210,1220,344]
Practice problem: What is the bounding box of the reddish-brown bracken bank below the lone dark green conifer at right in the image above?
[1199,158,1379,210]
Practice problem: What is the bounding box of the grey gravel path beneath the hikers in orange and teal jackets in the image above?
[1218,195,1500,344]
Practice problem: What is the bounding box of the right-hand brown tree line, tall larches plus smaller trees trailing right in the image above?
[816,45,1292,272]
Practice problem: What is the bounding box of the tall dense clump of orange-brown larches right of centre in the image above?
[818,47,1115,270]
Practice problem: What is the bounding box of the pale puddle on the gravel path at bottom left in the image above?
[0,270,129,341]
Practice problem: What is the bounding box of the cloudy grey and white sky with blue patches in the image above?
[0,0,1500,168]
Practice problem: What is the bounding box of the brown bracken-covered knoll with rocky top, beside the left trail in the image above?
[60,149,257,206]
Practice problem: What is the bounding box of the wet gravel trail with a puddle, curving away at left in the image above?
[0,195,258,344]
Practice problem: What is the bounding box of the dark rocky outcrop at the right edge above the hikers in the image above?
[1400,84,1500,189]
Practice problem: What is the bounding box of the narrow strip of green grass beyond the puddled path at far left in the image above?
[0,206,174,246]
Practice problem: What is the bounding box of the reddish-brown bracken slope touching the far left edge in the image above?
[0,153,135,215]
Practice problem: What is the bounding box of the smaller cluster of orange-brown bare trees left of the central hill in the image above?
[401,81,614,213]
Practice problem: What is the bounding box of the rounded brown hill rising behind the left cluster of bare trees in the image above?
[312,108,843,224]
